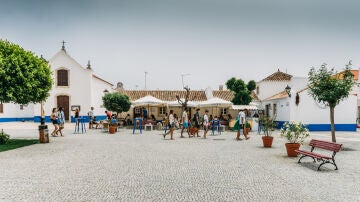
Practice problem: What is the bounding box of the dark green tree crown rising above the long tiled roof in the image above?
[226,77,256,105]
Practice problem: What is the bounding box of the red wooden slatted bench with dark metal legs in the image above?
[296,139,342,171]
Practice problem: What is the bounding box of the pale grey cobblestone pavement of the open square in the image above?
[0,123,360,201]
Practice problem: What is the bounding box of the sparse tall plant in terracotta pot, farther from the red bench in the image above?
[259,116,277,147]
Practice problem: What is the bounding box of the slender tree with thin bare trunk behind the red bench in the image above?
[308,62,354,142]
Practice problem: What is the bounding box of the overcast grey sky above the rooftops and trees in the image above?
[0,0,360,89]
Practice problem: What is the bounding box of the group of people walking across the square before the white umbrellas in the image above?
[163,108,250,140]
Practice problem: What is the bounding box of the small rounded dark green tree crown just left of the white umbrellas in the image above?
[102,92,131,114]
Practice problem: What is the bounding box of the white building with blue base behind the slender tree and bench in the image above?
[257,70,358,131]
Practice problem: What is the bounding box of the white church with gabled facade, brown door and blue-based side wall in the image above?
[0,46,114,122]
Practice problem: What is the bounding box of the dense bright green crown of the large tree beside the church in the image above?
[0,39,53,104]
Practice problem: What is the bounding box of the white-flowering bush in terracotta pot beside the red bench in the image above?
[280,121,310,157]
